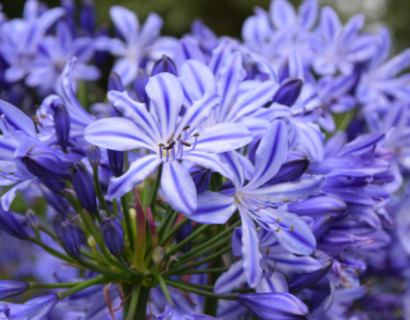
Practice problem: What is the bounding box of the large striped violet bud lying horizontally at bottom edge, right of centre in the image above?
[238,292,309,320]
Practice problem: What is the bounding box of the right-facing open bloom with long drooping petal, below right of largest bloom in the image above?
[190,120,325,287]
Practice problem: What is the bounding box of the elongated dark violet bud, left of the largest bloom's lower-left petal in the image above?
[72,162,98,213]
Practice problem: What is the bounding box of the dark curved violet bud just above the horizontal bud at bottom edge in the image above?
[288,257,333,292]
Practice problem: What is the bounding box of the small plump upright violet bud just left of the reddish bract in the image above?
[101,217,124,257]
